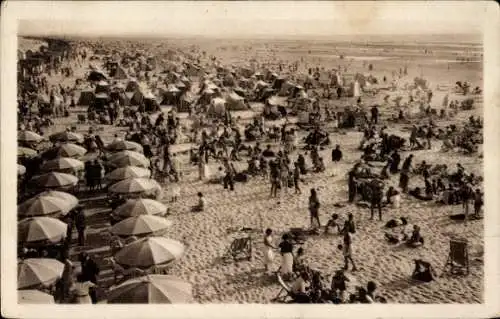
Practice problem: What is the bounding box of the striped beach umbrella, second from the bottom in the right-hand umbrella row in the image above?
[115,236,185,268]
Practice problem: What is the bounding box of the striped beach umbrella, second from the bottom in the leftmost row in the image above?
[17,258,64,289]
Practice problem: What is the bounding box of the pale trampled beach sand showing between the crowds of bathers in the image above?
[19,33,483,303]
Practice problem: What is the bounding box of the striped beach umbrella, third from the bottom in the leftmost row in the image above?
[17,217,68,243]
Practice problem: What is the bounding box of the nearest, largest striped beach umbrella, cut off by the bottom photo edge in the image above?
[108,275,193,304]
